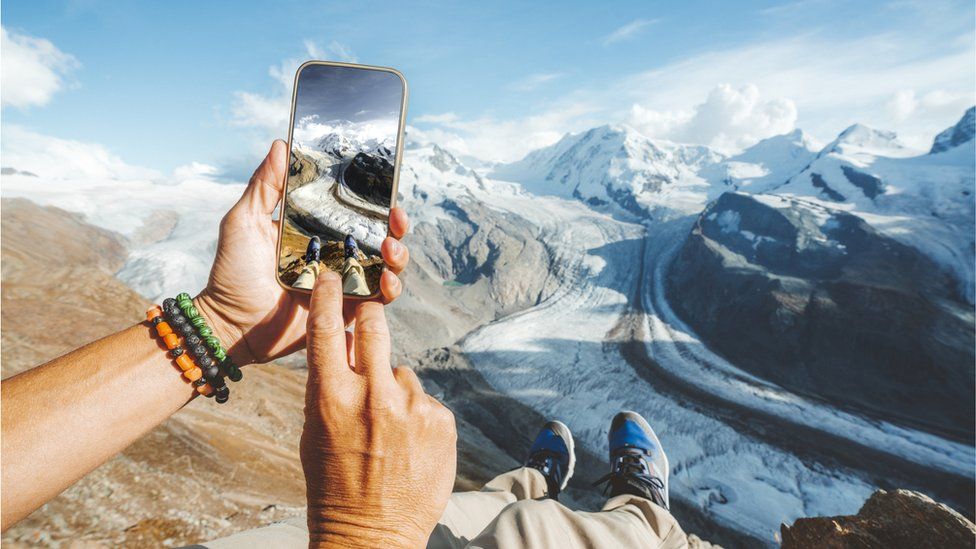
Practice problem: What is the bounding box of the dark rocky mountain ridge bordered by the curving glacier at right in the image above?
[667,193,974,441]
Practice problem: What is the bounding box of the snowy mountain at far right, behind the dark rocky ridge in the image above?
[771,109,976,302]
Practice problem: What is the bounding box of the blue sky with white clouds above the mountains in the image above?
[0,0,976,180]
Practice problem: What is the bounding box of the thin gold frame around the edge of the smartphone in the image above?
[274,61,410,300]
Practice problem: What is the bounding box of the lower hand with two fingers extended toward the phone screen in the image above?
[300,271,457,547]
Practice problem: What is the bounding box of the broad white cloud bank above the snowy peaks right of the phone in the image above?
[417,28,976,161]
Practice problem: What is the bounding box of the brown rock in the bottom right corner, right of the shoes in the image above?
[780,490,976,549]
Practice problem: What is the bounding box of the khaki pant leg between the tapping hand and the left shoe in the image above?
[427,467,546,549]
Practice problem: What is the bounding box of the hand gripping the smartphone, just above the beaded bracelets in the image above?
[194,140,410,366]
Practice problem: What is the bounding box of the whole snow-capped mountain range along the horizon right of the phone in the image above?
[490,109,974,301]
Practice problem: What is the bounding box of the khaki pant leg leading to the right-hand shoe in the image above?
[469,496,688,549]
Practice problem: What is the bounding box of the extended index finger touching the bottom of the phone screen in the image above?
[307,269,353,385]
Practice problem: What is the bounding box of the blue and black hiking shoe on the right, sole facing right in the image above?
[594,412,670,509]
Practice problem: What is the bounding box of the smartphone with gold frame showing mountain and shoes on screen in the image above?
[277,61,407,299]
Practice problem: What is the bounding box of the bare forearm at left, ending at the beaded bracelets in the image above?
[0,324,195,530]
